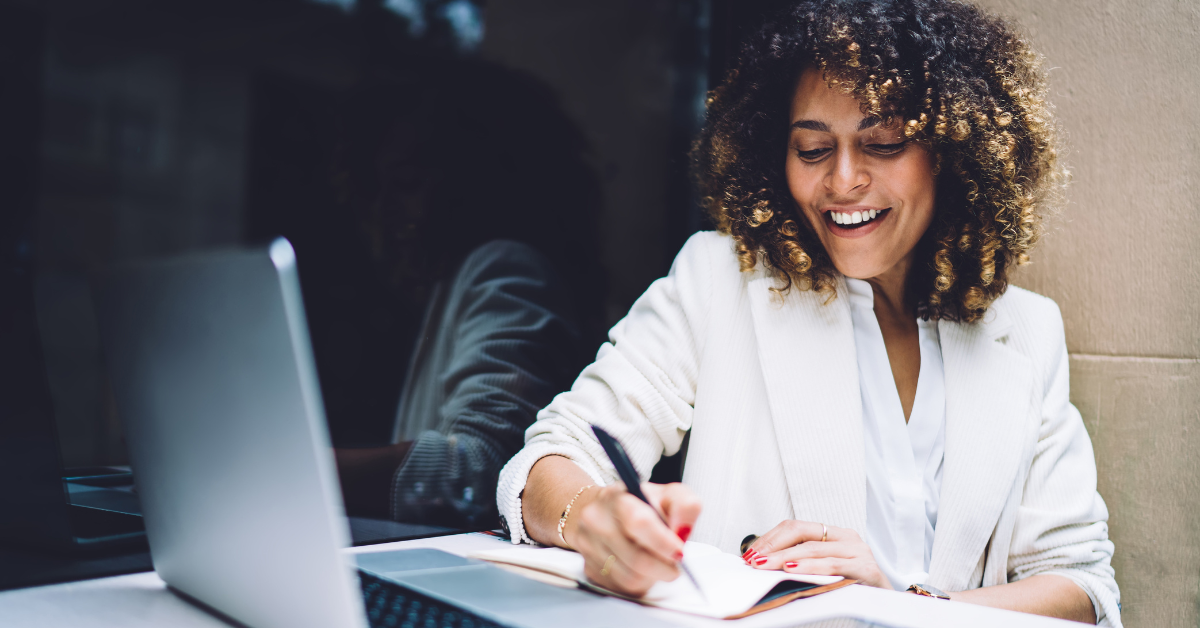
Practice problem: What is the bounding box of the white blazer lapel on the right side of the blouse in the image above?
[929,304,1036,591]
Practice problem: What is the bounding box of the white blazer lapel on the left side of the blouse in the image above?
[749,271,866,534]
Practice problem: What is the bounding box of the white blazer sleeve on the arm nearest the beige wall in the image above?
[1008,300,1121,627]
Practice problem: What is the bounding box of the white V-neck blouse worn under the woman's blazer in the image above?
[846,279,946,591]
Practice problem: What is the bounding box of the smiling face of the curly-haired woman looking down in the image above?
[787,70,936,281]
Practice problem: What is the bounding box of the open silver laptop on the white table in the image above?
[96,239,676,628]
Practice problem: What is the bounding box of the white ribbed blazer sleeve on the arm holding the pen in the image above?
[497,233,715,543]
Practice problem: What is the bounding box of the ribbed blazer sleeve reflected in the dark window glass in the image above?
[391,240,582,526]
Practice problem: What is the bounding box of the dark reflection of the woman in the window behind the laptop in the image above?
[336,58,602,528]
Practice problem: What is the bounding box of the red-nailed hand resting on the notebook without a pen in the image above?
[742,520,892,588]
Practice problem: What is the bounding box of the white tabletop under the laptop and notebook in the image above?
[0,534,1079,628]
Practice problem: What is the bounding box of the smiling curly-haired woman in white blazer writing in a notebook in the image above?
[498,0,1121,626]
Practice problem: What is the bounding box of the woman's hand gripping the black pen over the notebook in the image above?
[563,483,701,597]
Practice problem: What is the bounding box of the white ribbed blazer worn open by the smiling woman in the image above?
[497,232,1121,626]
